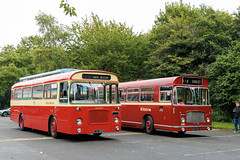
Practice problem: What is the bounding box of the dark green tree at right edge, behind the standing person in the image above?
[207,42,240,121]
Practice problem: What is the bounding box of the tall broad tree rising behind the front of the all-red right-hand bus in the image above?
[145,2,233,77]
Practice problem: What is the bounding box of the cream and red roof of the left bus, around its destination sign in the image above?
[12,70,119,89]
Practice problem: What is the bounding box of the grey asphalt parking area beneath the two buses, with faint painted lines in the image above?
[0,117,240,160]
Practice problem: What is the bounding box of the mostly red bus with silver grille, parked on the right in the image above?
[119,76,212,133]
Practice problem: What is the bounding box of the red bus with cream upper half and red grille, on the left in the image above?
[10,69,121,137]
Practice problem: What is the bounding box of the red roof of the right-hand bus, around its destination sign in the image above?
[119,75,208,88]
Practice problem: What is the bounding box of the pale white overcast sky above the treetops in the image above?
[0,0,240,49]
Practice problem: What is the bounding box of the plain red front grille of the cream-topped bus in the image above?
[89,110,109,123]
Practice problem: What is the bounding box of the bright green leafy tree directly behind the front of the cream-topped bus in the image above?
[68,14,147,81]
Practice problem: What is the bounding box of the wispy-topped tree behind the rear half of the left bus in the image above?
[16,12,70,75]
